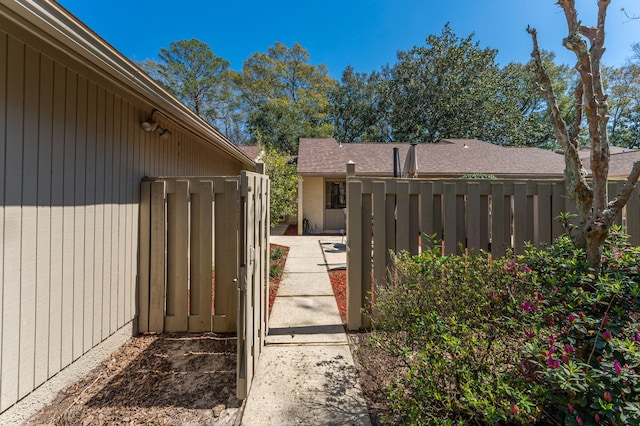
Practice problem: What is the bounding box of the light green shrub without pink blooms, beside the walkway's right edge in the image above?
[373,238,542,424]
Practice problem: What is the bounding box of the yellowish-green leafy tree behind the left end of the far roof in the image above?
[234,42,336,153]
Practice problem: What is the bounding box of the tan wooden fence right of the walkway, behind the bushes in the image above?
[347,170,640,330]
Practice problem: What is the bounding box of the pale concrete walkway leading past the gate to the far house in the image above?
[241,236,371,426]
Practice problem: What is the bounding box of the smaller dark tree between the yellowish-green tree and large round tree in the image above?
[329,66,391,142]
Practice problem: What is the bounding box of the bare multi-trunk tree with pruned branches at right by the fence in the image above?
[527,0,640,272]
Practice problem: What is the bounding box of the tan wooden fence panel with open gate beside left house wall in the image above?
[138,172,270,399]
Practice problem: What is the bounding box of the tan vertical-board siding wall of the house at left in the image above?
[0,31,242,411]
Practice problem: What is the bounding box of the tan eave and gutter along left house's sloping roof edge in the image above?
[0,0,256,169]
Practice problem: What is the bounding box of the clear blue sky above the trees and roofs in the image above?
[59,0,640,79]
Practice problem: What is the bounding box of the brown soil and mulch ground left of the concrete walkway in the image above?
[28,245,289,426]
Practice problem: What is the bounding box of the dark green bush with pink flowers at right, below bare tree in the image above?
[518,229,640,425]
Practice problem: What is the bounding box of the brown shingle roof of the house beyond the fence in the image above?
[298,138,564,177]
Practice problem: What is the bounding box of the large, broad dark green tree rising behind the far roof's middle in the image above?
[383,24,522,144]
